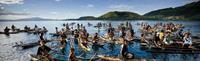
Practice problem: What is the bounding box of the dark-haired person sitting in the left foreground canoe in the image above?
[37,40,51,57]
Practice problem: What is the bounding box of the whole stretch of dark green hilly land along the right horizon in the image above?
[68,1,200,20]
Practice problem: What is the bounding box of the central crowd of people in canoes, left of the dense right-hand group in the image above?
[35,22,138,61]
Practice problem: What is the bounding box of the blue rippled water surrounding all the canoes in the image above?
[0,20,200,61]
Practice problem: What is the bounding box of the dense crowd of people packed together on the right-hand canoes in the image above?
[140,23,192,48]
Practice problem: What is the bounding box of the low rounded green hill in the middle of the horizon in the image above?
[98,11,142,20]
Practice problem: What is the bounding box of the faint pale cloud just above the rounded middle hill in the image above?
[109,4,134,11]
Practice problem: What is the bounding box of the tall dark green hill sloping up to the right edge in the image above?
[144,1,200,20]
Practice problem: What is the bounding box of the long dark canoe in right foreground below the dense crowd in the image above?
[140,43,200,54]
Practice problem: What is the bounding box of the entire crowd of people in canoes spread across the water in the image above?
[4,22,192,61]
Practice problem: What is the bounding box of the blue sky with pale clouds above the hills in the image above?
[0,0,198,20]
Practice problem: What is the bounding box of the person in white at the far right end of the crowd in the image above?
[183,32,192,48]
